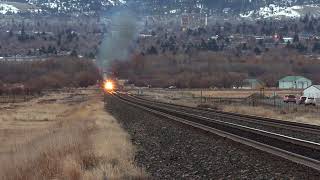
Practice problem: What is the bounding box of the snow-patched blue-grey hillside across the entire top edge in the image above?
[0,0,320,18]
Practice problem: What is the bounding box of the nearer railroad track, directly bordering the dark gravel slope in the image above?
[111,94,320,171]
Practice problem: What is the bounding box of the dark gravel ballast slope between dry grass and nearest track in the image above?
[106,97,320,179]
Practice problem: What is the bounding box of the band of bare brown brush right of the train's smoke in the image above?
[113,50,320,88]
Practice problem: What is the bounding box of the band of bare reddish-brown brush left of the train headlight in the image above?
[0,57,101,94]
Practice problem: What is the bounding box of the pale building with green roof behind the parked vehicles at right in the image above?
[279,76,312,89]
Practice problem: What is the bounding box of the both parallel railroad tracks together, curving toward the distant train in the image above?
[110,93,320,171]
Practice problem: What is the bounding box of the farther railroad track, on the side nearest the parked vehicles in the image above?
[129,95,320,143]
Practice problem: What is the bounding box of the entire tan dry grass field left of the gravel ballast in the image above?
[0,90,146,180]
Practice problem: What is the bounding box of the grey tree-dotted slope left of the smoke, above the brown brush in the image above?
[0,15,103,58]
